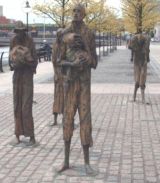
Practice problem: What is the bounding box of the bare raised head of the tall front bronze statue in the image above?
[73,4,86,22]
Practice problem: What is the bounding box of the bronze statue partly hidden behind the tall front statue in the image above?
[51,28,64,126]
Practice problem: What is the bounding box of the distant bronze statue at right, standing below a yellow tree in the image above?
[131,31,149,103]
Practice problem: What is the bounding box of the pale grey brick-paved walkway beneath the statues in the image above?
[0,44,160,183]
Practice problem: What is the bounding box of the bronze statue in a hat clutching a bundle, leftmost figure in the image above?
[10,21,38,145]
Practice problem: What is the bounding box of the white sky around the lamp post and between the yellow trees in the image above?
[0,0,120,23]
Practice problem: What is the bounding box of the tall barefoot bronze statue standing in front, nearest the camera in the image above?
[59,4,97,174]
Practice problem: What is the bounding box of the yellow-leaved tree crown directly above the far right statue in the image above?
[121,0,160,33]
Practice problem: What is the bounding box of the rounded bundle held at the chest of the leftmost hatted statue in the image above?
[10,45,33,65]
